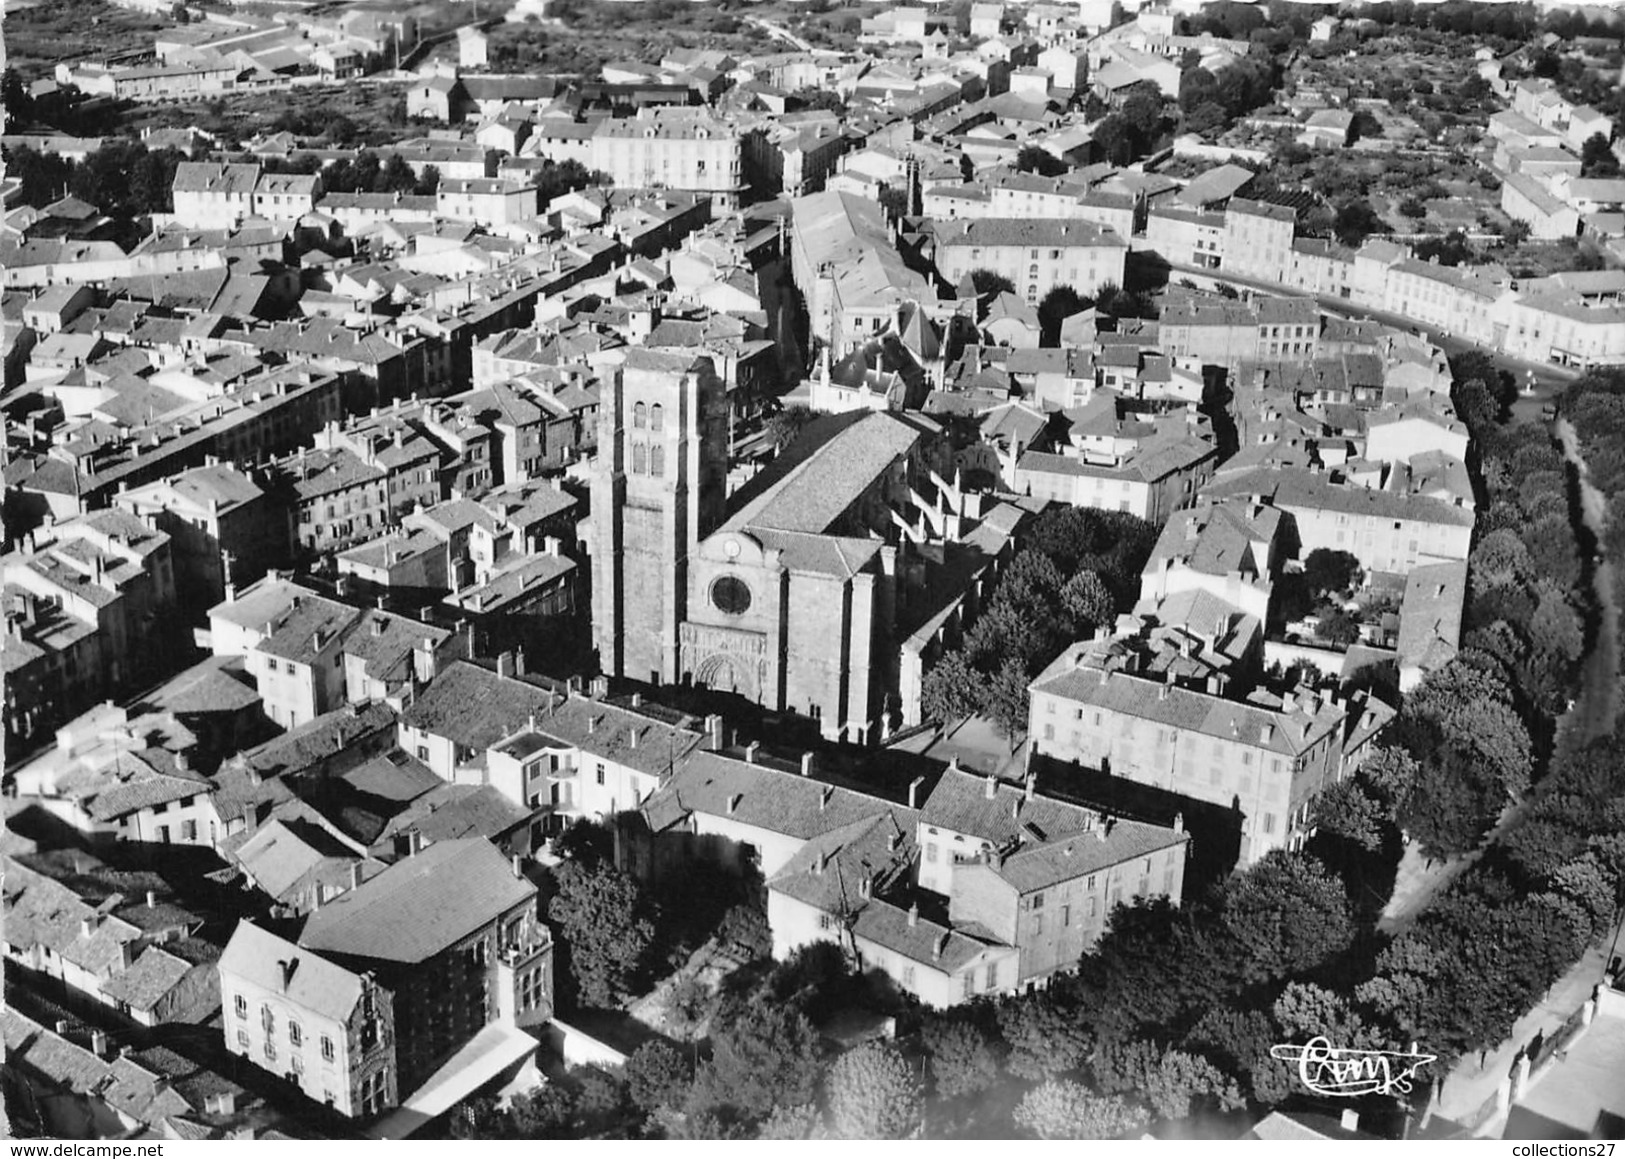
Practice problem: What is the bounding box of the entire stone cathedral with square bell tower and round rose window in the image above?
[592,349,1008,743]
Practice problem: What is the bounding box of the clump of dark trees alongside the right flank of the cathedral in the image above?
[921,507,1157,736]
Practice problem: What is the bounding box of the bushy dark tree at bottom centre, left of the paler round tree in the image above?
[691,998,821,1118]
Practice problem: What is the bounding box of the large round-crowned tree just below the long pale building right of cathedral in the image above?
[1220,849,1354,983]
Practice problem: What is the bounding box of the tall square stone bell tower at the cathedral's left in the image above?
[592,348,728,684]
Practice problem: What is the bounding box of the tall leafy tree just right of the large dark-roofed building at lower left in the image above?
[548,862,655,1008]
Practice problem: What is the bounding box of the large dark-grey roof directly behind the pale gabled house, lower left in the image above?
[299,837,536,964]
